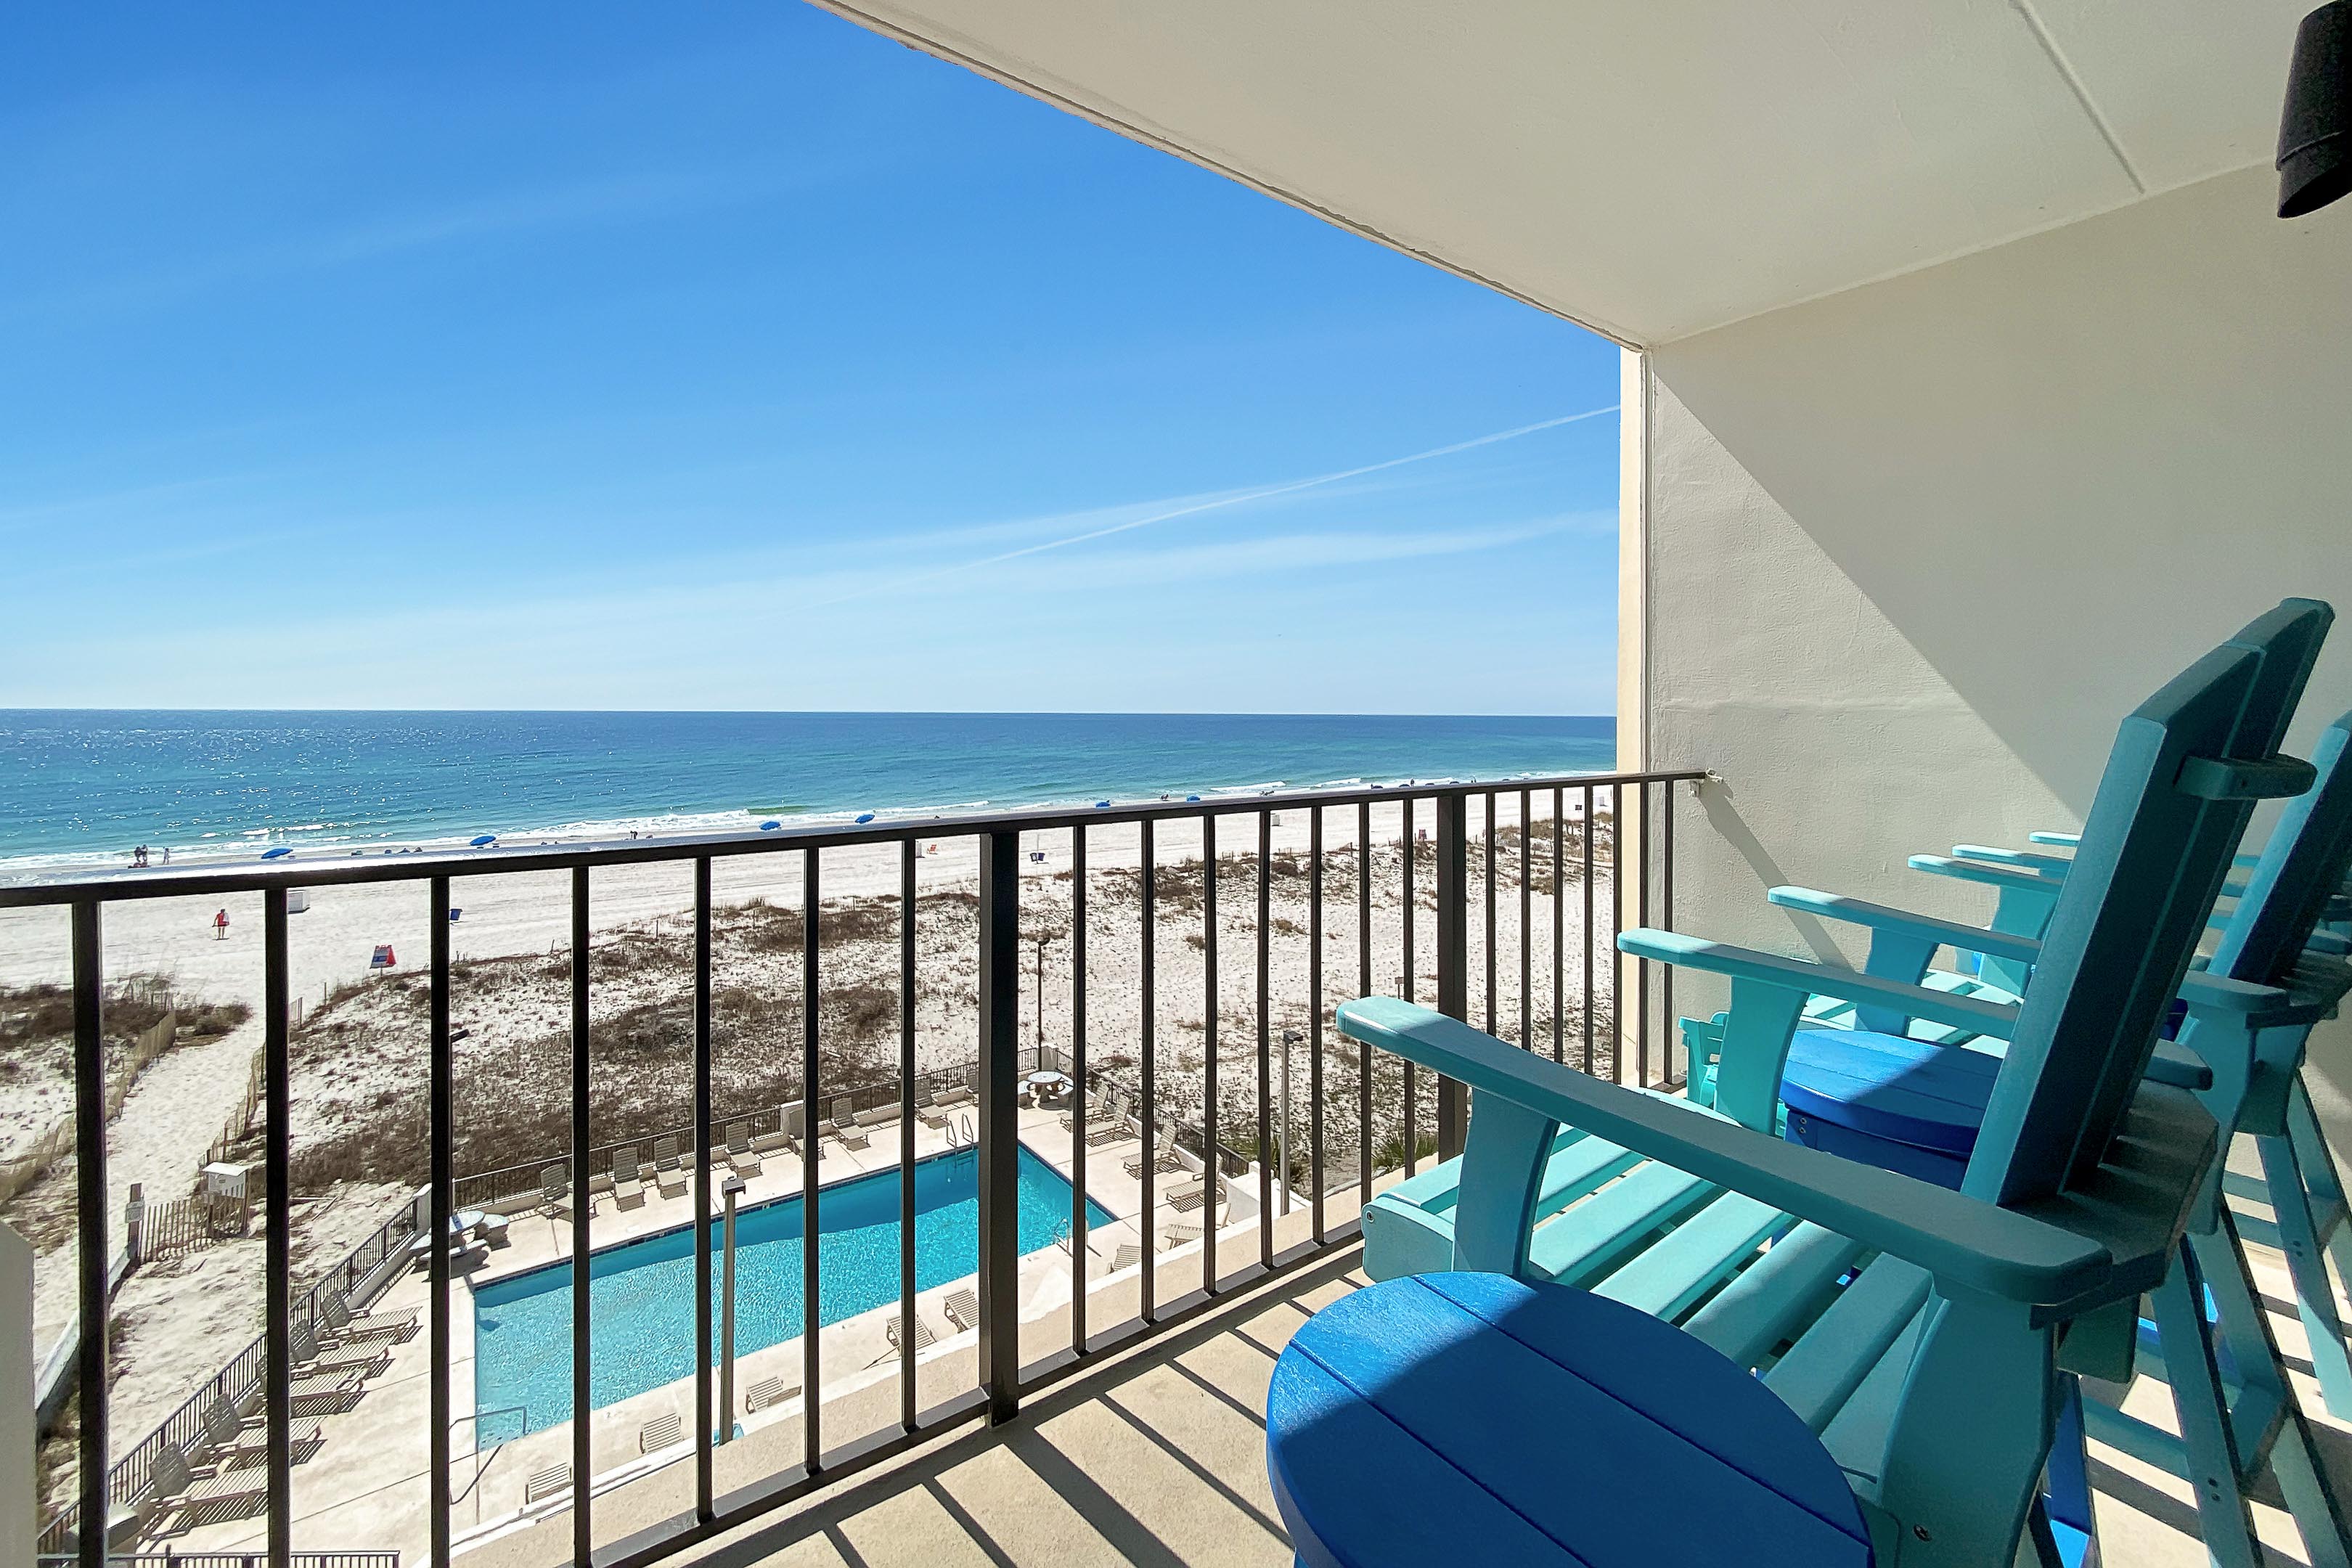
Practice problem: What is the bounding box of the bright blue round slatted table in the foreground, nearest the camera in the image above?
[1265,1274,1872,1568]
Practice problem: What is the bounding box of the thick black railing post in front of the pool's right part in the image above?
[973,830,1021,1422]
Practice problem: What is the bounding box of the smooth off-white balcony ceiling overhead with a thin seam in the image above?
[821,0,2314,346]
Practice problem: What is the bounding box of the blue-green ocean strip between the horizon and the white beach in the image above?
[0,710,1616,872]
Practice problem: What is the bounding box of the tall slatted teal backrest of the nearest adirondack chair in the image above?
[1961,600,2333,1204]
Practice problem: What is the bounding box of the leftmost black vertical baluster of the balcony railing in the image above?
[73,898,113,1568]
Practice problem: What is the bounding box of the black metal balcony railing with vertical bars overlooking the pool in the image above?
[0,771,1705,1568]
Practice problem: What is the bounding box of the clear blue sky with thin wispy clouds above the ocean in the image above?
[0,0,1618,712]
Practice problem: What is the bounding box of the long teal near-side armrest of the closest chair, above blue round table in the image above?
[1339,1001,2115,1307]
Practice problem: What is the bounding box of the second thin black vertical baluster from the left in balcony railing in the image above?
[261,886,294,1568]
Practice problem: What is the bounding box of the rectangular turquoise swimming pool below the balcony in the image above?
[473,1147,1113,1443]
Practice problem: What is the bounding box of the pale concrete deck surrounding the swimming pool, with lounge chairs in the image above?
[146,1107,1270,1561]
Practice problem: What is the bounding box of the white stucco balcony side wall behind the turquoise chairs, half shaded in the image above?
[1625,169,2352,1147]
